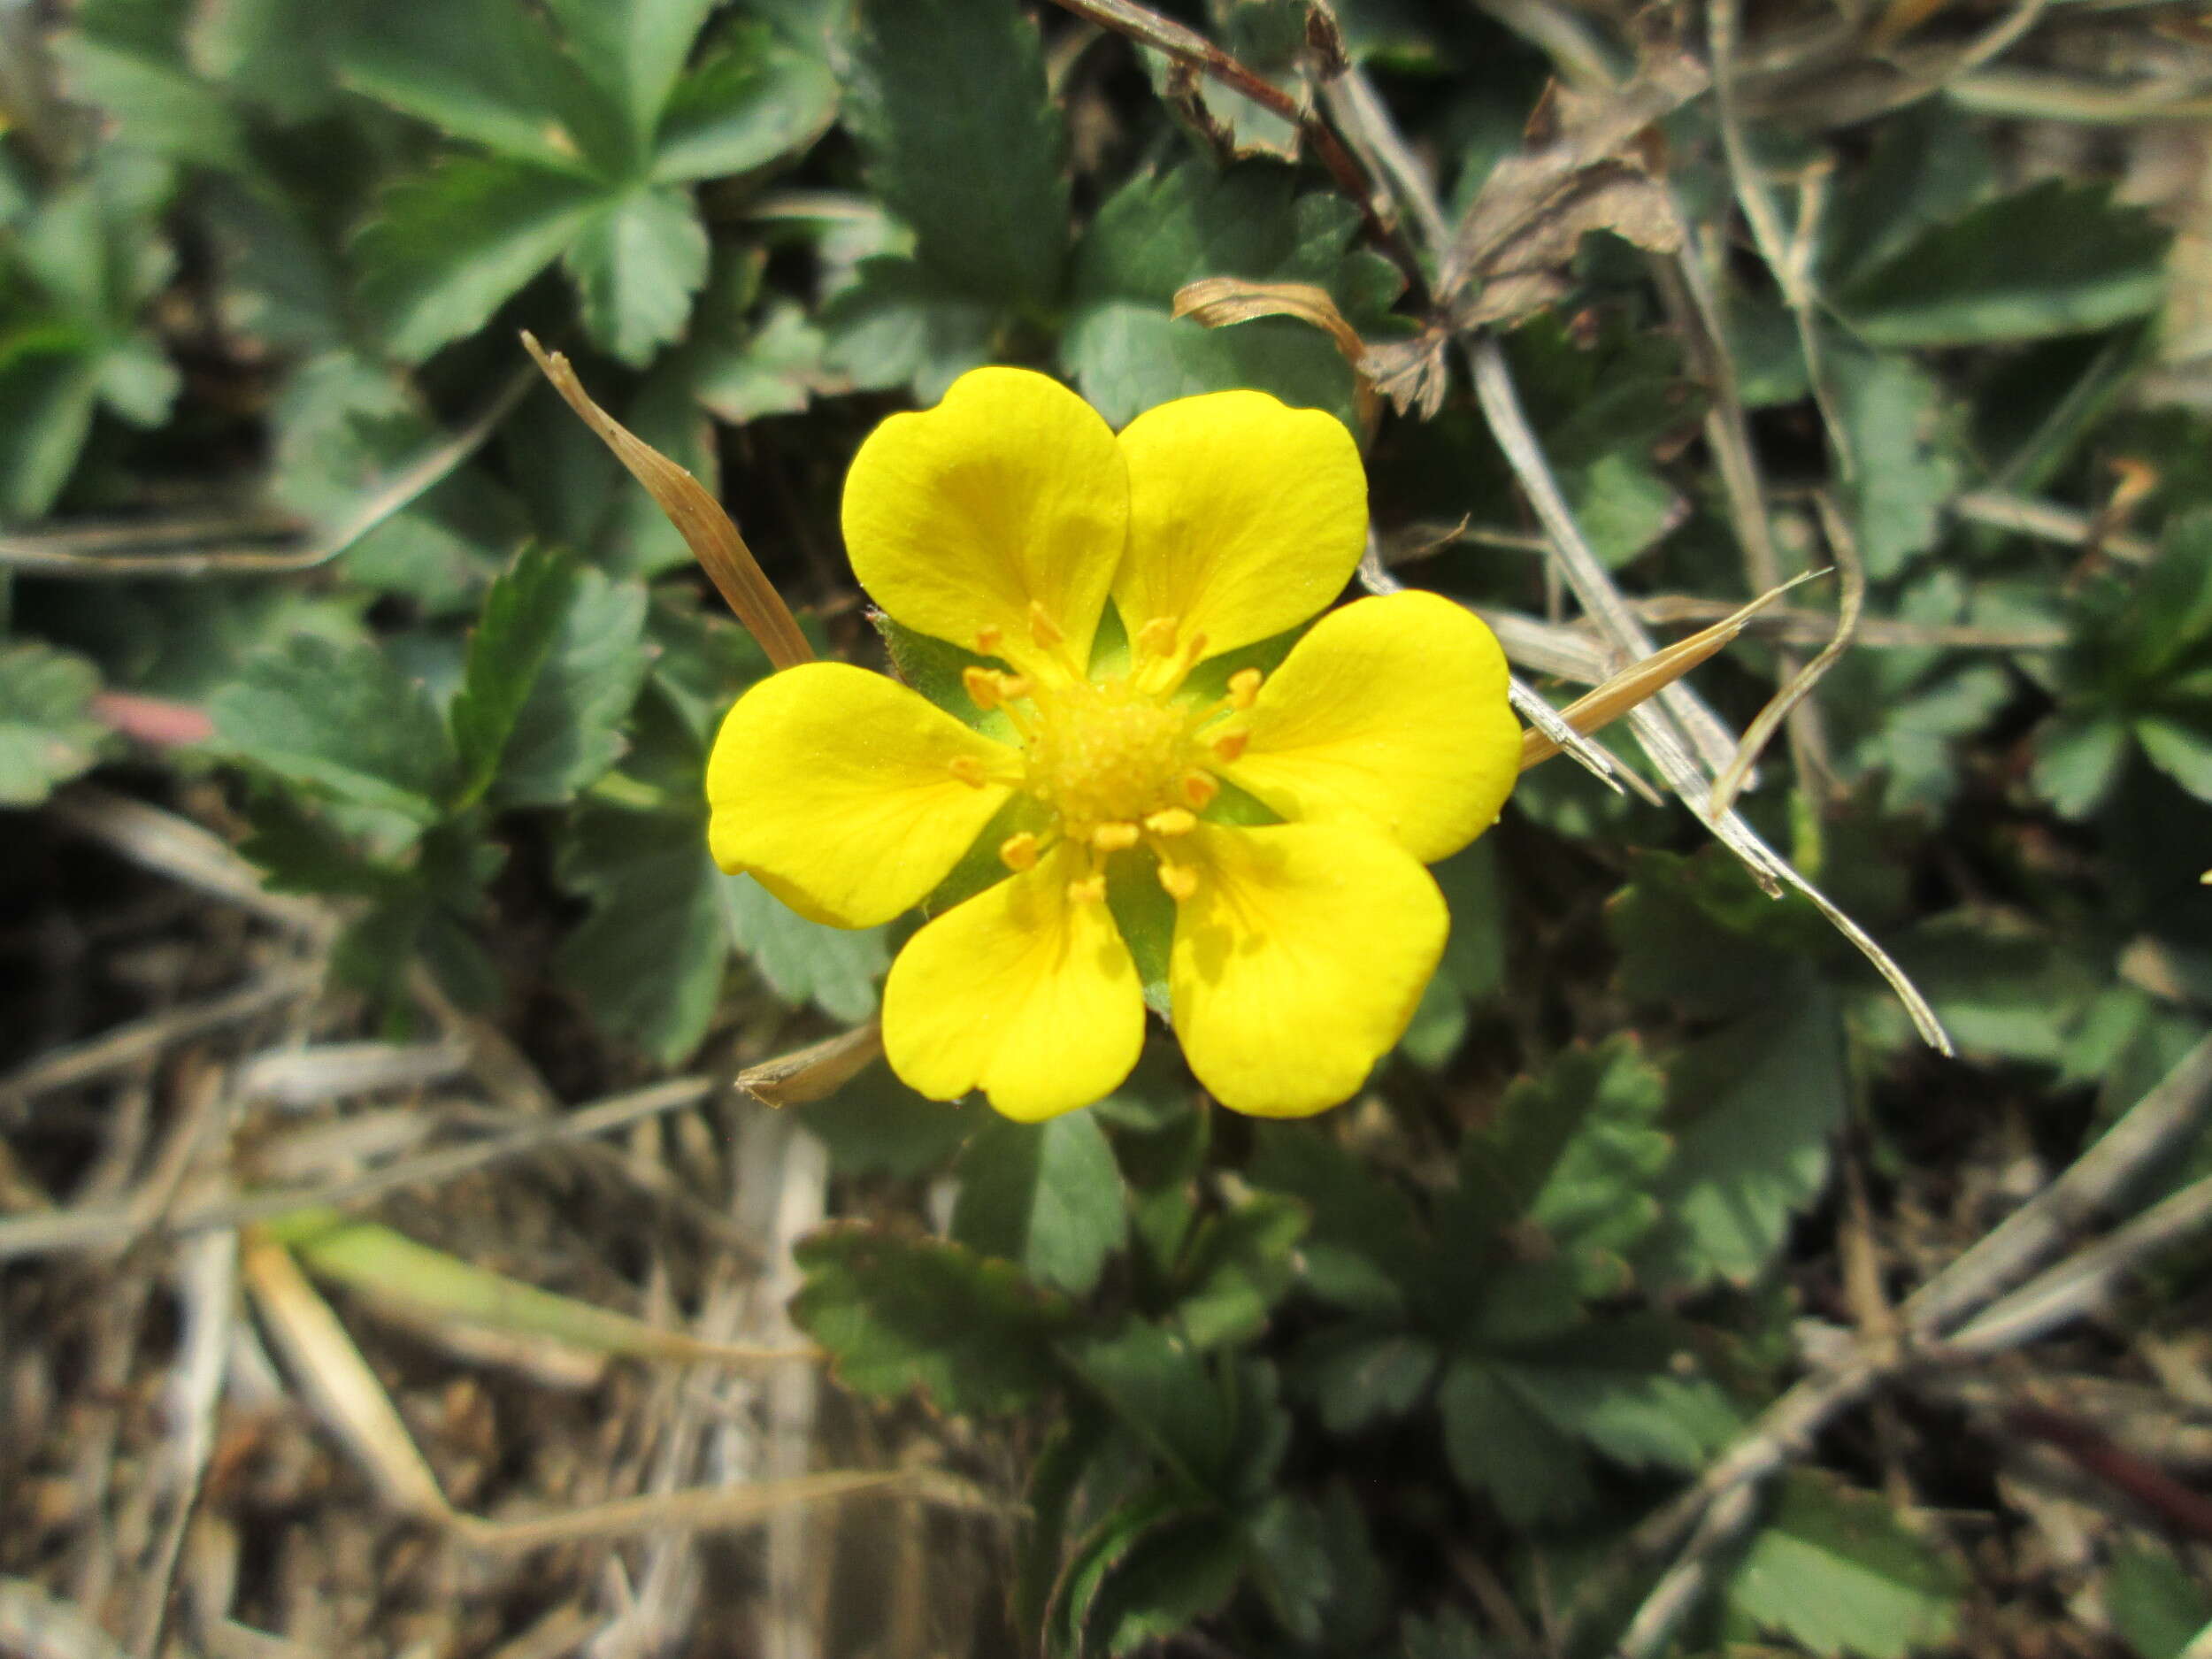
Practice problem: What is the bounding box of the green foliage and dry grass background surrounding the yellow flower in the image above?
[0,0,2212,1659]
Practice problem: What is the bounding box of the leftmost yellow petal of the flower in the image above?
[706,662,1022,927]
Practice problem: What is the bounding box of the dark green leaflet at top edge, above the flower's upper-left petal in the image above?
[849,0,1069,305]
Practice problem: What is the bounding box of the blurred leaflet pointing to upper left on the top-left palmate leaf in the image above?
[339,0,619,173]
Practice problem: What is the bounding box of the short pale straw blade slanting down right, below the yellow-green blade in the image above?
[242,1230,454,1522]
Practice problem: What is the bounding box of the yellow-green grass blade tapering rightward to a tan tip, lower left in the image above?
[268,1210,821,1365]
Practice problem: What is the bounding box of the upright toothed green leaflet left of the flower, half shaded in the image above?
[489,571,653,808]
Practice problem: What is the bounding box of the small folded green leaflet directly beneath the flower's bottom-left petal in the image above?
[951,1113,1128,1296]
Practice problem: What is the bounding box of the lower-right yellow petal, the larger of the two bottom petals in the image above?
[1168,823,1449,1118]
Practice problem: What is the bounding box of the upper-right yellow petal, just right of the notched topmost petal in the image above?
[1113,392,1367,657]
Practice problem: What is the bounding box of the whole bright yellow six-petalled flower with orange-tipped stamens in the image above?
[708,370,1520,1122]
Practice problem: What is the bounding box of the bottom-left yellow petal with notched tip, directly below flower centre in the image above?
[883,841,1144,1124]
